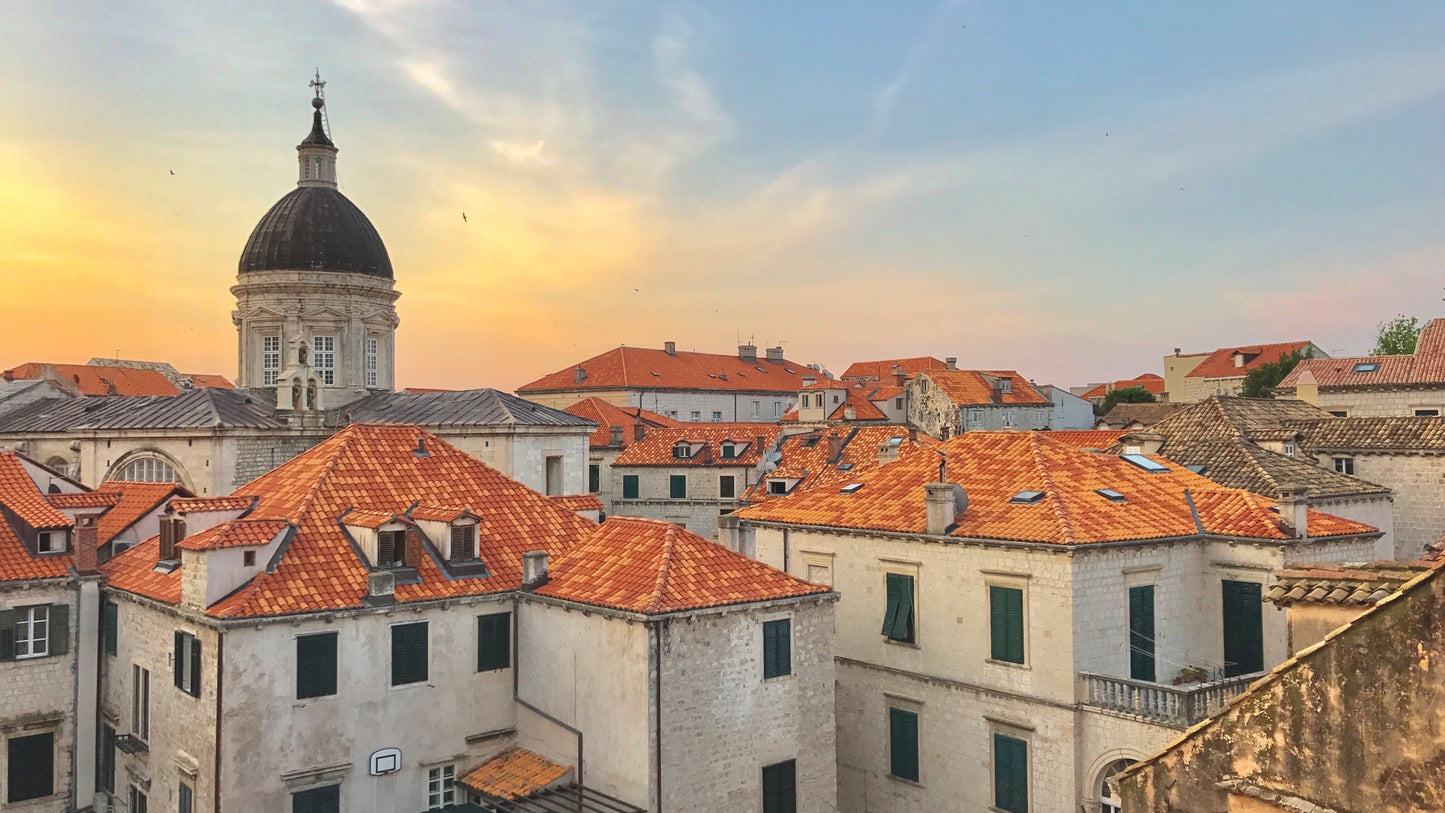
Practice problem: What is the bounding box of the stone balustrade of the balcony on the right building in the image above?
[1079,671,1264,728]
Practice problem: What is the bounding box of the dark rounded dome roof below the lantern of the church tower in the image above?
[240,186,392,279]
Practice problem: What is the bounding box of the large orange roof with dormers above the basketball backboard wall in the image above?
[104,423,594,618]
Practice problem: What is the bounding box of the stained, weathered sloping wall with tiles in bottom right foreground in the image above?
[1118,563,1445,813]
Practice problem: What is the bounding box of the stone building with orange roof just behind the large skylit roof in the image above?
[906,370,1053,439]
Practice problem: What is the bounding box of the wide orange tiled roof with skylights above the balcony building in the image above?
[737,432,1376,544]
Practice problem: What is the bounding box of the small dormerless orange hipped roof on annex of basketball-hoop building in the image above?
[533,517,828,614]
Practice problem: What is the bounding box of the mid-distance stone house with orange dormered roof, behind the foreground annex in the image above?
[608,423,782,539]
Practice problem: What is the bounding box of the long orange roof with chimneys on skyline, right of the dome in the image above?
[517,347,816,396]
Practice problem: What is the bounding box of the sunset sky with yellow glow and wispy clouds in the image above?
[0,0,1445,390]
